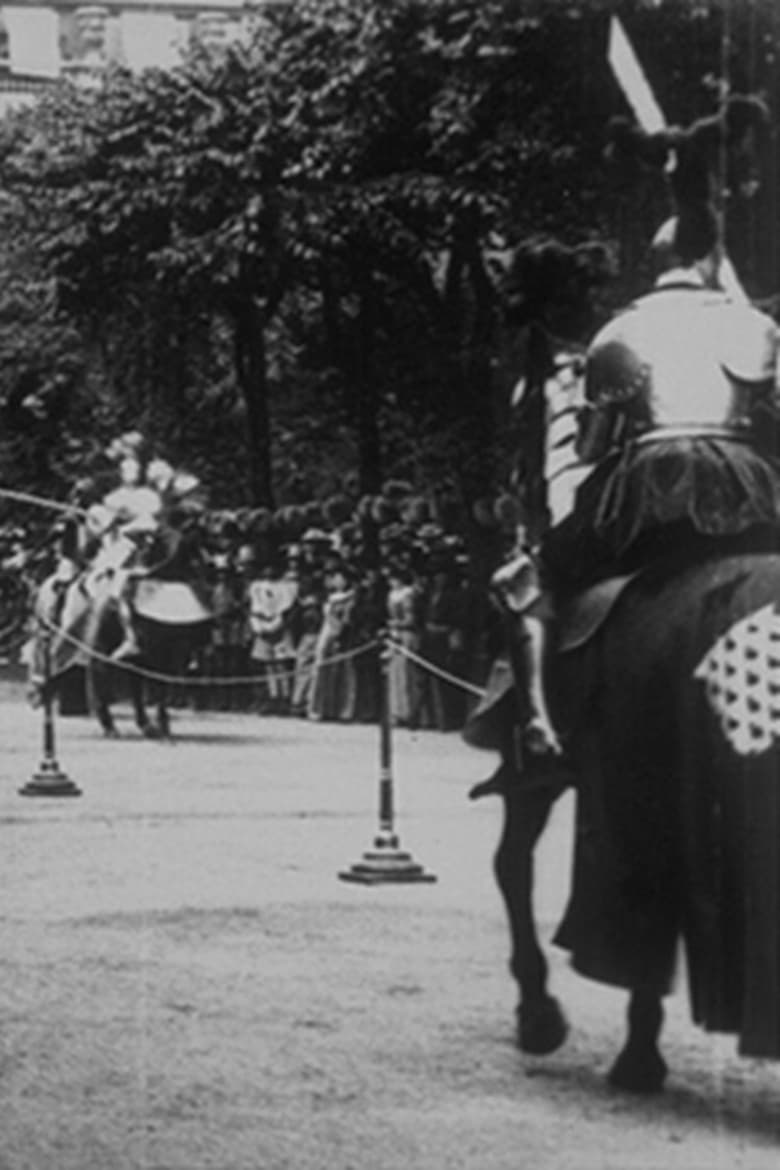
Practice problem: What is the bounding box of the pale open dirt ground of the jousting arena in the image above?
[0,686,780,1170]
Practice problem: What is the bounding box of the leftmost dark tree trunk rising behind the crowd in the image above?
[234,297,274,508]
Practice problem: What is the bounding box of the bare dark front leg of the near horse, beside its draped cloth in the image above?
[493,776,568,1055]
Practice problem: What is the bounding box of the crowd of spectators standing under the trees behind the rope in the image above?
[0,496,509,730]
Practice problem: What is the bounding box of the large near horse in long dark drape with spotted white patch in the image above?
[465,551,780,1092]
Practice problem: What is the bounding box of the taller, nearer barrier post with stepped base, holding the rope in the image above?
[339,633,436,886]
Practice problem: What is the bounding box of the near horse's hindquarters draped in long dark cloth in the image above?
[555,556,780,1057]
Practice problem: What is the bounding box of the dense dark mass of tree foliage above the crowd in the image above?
[0,0,779,524]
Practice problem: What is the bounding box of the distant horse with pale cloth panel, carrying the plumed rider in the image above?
[33,533,210,737]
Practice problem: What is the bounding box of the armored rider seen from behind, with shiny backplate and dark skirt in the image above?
[493,204,780,756]
